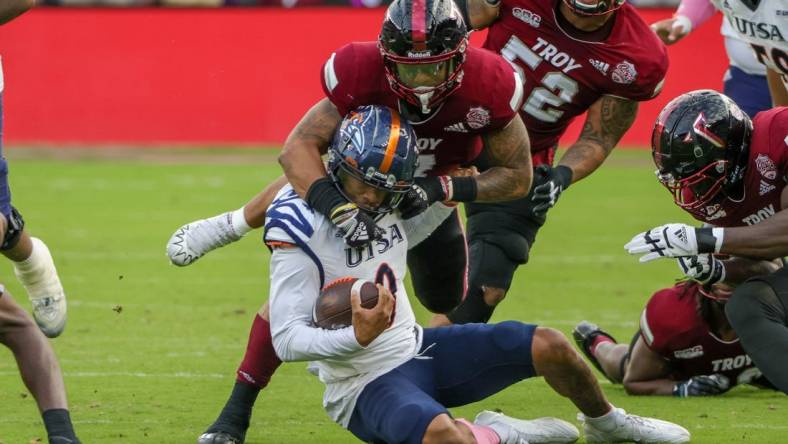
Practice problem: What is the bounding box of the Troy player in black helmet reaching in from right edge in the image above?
[625,90,788,392]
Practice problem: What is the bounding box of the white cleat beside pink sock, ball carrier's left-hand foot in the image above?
[473,410,580,444]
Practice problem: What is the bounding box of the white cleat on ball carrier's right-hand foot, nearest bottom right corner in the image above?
[578,409,690,443]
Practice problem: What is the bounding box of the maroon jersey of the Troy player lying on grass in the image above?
[640,283,761,385]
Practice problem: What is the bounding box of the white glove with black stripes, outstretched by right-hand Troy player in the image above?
[624,224,723,262]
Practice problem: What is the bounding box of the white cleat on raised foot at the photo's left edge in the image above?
[14,237,66,338]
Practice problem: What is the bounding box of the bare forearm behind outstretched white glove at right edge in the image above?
[715,187,788,259]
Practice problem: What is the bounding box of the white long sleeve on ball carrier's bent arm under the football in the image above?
[269,248,363,361]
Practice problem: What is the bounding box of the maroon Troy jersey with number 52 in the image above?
[484,0,668,164]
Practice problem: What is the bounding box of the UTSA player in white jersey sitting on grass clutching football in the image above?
[246,106,689,443]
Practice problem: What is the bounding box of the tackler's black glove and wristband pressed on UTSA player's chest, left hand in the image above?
[306,177,386,248]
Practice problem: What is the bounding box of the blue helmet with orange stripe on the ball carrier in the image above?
[328,105,418,213]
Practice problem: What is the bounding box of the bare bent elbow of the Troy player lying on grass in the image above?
[623,337,676,395]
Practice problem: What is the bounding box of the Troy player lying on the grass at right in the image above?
[572,255,779,397]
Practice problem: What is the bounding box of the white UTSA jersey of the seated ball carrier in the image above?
[265,185,451,427]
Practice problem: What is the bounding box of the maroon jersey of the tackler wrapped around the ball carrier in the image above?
[322,42,523,175]
